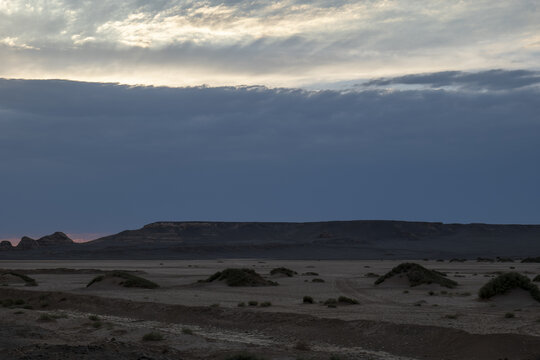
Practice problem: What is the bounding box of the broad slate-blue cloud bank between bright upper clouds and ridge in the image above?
[0,72,540,238]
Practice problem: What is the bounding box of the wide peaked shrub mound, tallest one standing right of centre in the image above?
[375,263,457,288]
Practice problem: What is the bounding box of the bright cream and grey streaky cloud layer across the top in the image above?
[0,0,540,88]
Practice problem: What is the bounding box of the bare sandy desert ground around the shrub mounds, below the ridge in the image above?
[0,259,540,360]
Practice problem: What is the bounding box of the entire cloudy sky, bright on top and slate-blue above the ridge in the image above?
[0,0,540,243]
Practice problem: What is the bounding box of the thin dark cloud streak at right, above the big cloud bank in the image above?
[363,69,540,90]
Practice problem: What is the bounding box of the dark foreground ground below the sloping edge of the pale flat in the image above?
[0,289,540,360]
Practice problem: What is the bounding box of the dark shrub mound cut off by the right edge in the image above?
[478,272,540,302]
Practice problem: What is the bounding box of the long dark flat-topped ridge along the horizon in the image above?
[0,220,540,259]
